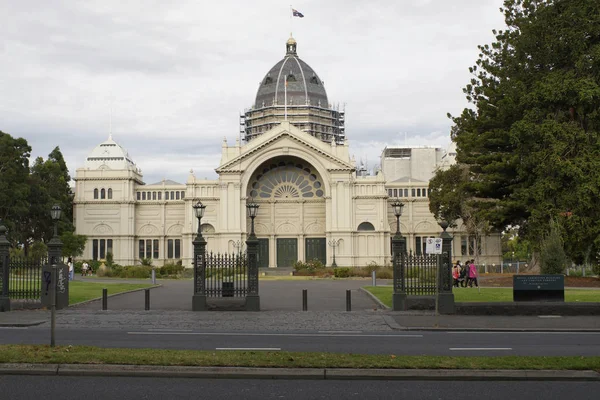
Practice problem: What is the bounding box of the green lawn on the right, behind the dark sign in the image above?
[365,286,600,307]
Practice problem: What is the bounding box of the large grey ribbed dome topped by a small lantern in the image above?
[254,38,329,108]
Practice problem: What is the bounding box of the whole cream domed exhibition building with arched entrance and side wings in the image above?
[74,38,501,268]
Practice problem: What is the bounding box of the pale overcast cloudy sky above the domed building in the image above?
[0,0,505,183]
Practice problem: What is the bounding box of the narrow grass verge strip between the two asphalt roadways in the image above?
[0,345,600,371]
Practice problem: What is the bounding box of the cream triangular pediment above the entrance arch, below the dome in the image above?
[216,122,355,174]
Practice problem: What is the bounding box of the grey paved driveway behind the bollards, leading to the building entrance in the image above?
[72,279,377,311]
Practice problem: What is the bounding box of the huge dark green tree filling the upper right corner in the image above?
[452,0,600,263]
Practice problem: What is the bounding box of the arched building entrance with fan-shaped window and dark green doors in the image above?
[246,155,326,267]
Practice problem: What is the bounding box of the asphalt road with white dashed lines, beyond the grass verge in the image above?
[0,326,600,356]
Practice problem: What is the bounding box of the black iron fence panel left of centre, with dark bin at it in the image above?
[205,253,248,297]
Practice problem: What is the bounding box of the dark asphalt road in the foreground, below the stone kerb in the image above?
[0,375,600,400]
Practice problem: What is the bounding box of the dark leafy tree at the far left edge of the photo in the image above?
[0,131,31,245]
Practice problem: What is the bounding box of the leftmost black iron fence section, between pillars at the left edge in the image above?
[8,257,46,300]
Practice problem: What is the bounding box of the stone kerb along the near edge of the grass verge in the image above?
[0,364,600,382]
